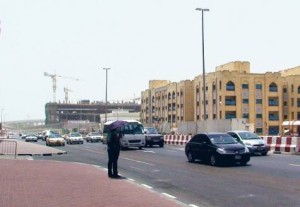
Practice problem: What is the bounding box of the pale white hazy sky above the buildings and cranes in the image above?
[0,0,300,121]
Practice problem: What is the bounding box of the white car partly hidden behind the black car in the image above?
[227,131,270,155]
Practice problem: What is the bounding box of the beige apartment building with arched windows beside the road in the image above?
[141,61,300,135]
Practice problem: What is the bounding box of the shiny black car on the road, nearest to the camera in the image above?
[185,133,250,165]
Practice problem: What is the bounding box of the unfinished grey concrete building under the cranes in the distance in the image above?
[45,100,141,124]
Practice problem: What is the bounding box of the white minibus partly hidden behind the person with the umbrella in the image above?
[103,120,146,149]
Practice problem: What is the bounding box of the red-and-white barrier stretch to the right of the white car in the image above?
[262,136,300,154]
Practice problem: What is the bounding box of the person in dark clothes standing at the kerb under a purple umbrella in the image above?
[107,121,127,178]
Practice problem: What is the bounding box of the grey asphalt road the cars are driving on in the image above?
[27,141,300,207]
